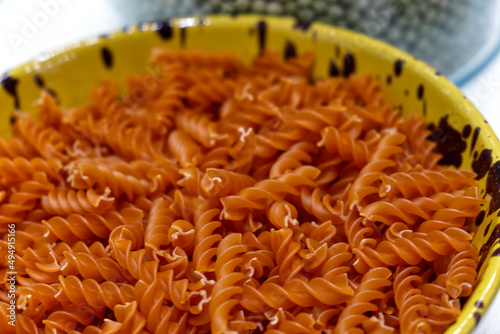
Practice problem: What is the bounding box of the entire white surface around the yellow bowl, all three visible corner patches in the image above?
[0,0,500,334]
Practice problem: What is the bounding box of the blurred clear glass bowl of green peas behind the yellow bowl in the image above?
[107,0,500,84]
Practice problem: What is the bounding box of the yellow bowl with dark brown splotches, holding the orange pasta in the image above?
[0,16,500,333]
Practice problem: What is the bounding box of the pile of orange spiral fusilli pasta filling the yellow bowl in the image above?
[0,49,485,334]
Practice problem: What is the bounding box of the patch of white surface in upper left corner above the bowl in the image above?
[0,0,123,73]
